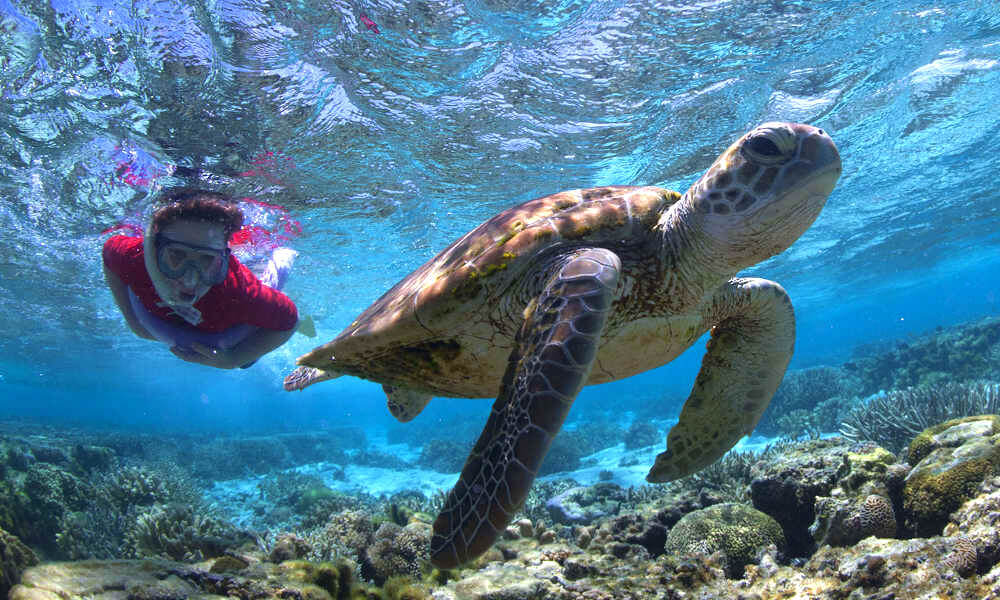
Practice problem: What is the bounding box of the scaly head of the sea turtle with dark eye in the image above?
[685,123,841,268]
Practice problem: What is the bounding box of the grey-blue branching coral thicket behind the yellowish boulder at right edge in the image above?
[840,382,1000,452]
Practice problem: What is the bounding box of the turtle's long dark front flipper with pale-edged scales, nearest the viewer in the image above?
[431,248,621,568]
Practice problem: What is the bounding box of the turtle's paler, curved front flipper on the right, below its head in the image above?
[646,278,795,483]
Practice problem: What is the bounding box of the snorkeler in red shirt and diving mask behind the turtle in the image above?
[103,188,298,369]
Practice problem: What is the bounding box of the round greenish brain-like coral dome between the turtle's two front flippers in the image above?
[664,503,785,578]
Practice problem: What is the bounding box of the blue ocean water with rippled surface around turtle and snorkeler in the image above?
[0,0,1000,446]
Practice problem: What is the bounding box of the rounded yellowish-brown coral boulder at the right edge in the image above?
[903,415,1000,536]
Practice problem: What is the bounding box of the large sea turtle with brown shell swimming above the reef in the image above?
[285,123,841,568]
